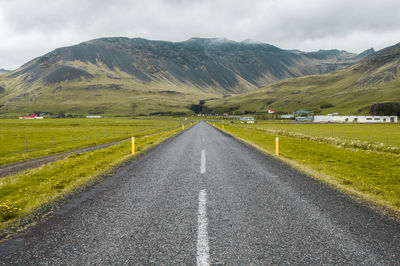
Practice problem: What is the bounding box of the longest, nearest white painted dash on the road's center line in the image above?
[197,189,210,266]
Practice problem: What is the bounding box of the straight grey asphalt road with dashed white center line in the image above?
[0,123,400,265]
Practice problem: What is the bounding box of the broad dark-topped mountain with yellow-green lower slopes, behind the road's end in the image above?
[0,38,368,114]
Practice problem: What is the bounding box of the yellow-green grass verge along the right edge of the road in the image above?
[217,124,400,217]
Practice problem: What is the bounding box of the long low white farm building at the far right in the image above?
[314,115,398,123]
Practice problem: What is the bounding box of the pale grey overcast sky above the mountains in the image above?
[0,0,400,69]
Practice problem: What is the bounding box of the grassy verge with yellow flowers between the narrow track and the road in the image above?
[0,124,191,237]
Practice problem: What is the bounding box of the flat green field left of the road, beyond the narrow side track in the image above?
[0,117,188,165]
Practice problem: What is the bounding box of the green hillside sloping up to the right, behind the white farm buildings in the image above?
[202,43,400,115]
